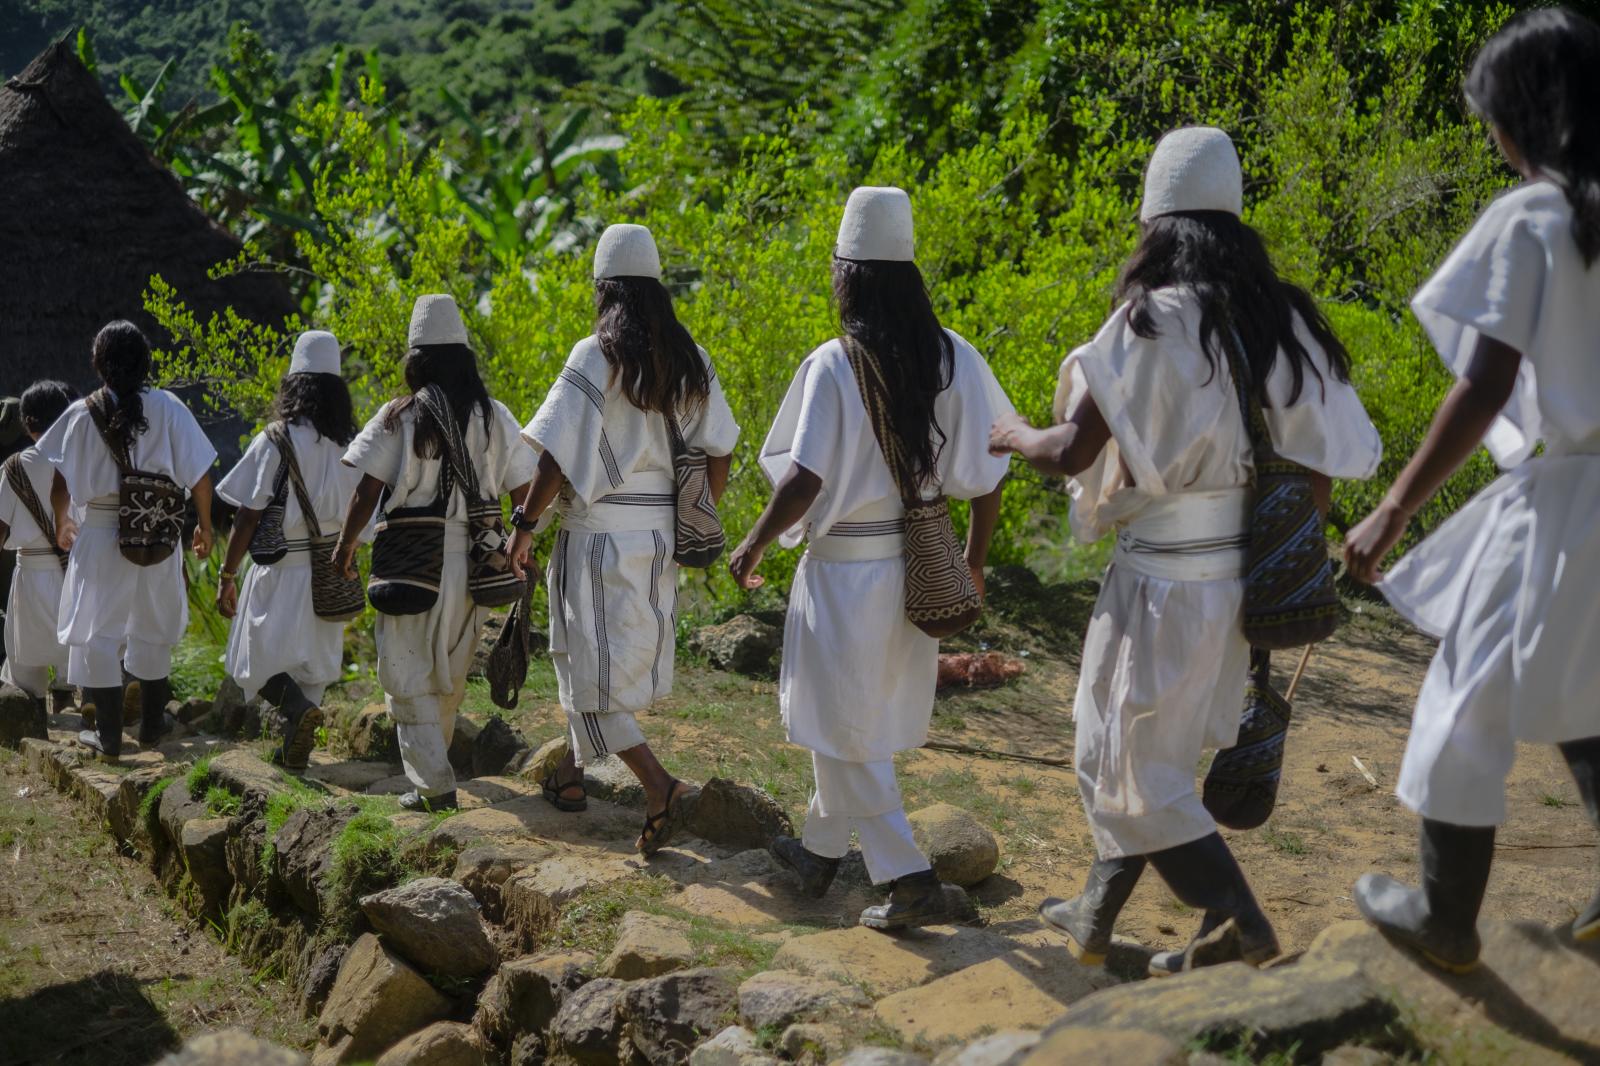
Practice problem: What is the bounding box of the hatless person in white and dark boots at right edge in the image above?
[1346,10,1600,972]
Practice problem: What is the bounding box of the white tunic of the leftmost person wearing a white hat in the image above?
[216,423,365,699]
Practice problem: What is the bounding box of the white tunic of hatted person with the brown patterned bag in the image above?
[760,331,1013,765]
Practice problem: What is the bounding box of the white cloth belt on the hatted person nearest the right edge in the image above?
[1112,488,1254,581]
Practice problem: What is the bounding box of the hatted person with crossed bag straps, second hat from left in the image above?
[334,295,536,810]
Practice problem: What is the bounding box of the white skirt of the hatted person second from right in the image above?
[1072,560,1250,858]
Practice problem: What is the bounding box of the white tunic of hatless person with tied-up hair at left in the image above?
[38,389,216,647]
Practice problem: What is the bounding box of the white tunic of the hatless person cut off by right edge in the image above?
[1381,182,1600,745]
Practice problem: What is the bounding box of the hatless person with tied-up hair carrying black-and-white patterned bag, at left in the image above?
[38,322,216,760]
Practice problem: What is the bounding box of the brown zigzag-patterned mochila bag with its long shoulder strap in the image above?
[843,338,984,639]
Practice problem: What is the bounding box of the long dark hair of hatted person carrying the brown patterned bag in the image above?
[834,256,955,485]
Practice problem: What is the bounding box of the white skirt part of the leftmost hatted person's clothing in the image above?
[222,551,344,699]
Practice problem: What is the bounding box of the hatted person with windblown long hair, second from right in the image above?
[994,126,1382,975]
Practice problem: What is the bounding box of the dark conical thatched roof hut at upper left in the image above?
[0,42,293,450]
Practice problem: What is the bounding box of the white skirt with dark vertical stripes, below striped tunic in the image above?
[547,528,678,713]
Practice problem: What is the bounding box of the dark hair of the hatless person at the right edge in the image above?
[1464,8,1600,266]
